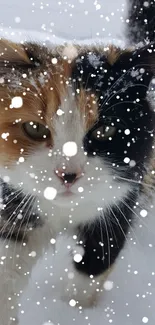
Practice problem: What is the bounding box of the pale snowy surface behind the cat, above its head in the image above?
[0,0,127,39]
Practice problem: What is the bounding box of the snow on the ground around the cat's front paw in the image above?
[20,202,155,325]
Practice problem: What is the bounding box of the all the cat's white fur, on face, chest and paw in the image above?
[0,92,129,325]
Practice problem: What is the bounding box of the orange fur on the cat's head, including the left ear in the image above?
[0,41,98,166]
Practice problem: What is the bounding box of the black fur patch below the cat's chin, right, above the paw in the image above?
[74,187,138,276]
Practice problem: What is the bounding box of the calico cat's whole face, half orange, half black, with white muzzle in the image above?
[0,39,153,228]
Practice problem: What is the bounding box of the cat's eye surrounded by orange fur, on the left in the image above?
[22,121,50,141]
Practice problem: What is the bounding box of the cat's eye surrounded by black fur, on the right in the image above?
[91,125,116,141]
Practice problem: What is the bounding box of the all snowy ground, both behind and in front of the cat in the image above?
[0,0,155,325]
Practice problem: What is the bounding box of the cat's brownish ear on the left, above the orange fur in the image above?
[0,39,40,73]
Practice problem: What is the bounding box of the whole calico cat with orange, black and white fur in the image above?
[0,2,155,325]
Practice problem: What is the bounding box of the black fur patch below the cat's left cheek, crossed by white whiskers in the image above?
[0,182,42,241]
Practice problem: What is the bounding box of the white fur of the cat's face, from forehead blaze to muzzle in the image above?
[0,92,130,232]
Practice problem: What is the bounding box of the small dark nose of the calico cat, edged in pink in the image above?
[55,169,82,187]
